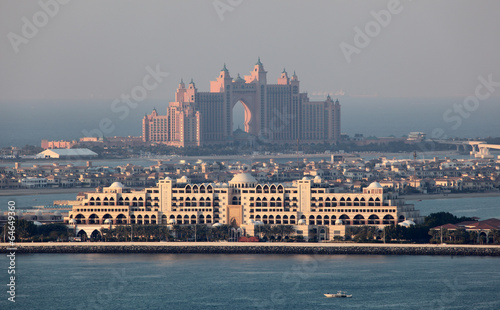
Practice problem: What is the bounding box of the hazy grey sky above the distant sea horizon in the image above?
[0,0,500,104]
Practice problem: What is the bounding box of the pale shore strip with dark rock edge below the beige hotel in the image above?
[0,242,500,256]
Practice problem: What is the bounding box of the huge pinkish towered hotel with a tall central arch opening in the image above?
[142,59,340,147]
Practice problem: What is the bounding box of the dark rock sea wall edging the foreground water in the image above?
[0,244,500,256]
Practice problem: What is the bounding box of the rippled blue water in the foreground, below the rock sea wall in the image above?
[0,254,500,310]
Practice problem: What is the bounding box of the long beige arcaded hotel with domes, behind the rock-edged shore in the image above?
[65,173,422,240]
